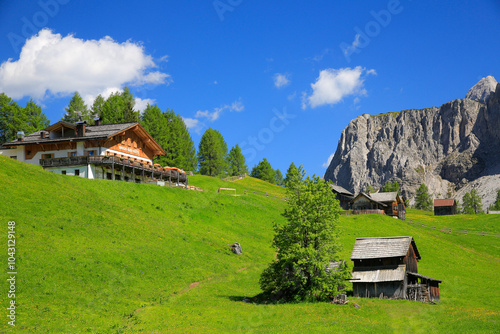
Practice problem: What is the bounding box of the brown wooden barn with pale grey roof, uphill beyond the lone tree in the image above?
[352,192,406,219]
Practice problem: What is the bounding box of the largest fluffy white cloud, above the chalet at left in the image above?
[0,29,171,100]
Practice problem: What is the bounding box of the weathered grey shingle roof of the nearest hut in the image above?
[351,237,420,260]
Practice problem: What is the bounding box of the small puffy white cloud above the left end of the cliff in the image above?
[302,66,376,109]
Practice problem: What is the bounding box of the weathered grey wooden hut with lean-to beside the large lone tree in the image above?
[351,237,441,301]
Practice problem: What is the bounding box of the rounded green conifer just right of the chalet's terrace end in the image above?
[198,128,227,176]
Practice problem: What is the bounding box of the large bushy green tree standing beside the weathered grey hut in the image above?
[260,177,350,301]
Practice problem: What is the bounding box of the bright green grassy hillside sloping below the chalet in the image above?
[0,156,500,333]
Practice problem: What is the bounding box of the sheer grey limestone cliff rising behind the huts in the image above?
[324,77,500,208]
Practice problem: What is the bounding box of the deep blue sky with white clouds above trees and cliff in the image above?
[0,0,500,176]
